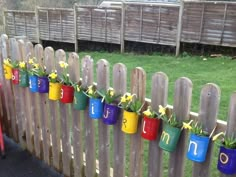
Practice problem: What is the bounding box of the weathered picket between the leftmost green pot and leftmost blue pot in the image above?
[23,42,34,153]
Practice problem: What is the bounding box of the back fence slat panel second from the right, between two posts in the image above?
[124,3,179,46]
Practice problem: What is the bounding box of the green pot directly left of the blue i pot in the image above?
[74,91,88,110]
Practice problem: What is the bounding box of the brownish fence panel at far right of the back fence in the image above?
[181,2,236,47]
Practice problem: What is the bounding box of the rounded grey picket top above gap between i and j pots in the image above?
[96,59,109,90]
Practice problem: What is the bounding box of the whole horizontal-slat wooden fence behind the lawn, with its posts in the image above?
[4,1,236,54]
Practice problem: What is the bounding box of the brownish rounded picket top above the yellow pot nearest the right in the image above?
[131,67,146,101]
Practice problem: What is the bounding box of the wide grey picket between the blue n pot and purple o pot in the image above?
[193,84,220,177]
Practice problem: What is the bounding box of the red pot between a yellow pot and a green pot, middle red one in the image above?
[61,85,74,103]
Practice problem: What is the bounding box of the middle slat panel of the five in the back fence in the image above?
[75,5,122,44]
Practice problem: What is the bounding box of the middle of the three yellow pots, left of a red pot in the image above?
[48,82,61,101]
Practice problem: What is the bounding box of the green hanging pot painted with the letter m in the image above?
[159,123,181,152]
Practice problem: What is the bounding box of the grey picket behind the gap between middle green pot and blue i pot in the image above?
[82,55,96,177]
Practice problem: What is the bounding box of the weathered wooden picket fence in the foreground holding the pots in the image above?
[0,34,236,177]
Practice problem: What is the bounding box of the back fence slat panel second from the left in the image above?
[37,7,75,43]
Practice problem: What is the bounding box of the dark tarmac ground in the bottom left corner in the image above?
[0,137,63,177]
